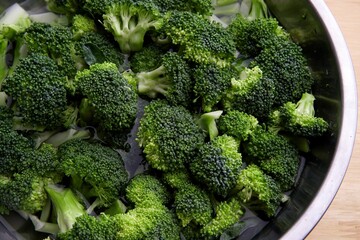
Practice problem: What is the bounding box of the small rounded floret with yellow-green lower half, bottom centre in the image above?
[126,174,170,207]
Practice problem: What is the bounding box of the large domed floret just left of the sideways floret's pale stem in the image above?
[75,62,137,131]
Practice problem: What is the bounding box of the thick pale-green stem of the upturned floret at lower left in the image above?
[45,185,86,233]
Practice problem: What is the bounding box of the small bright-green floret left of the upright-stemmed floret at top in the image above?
[71,14,96,39]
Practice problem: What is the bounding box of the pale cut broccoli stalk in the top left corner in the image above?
[0,4,31,86]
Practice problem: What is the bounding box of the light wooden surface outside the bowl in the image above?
[307,0,360,240]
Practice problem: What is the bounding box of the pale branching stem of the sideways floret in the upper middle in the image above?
[137,65,169,98]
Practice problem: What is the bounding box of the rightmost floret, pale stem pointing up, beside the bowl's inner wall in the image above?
[269,93,329,137]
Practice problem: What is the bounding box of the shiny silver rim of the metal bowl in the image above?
[281,0,358,239]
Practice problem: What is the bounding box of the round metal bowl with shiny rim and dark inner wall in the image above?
[0,0,357,240]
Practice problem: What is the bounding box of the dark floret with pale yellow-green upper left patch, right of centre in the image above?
[222,66,277,120]
